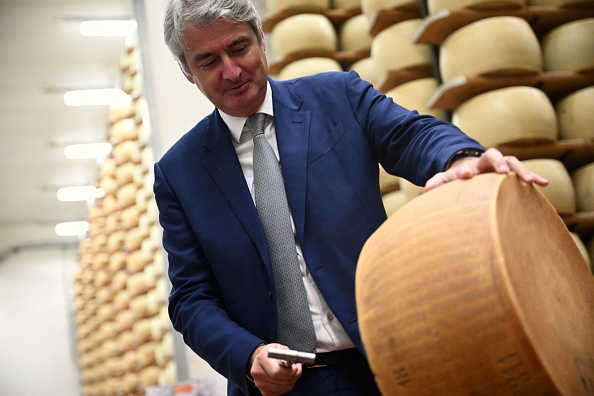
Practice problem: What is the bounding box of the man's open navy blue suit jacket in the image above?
[154,73,482,395]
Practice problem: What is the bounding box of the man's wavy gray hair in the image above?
[163,0,262,74]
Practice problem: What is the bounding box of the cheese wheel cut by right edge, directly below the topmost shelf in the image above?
[542,18,594,72]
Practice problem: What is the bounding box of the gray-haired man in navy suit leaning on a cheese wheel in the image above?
[154,0,547,396]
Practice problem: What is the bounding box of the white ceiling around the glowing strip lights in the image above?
[0,0,131,262]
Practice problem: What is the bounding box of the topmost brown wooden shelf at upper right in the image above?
[413,2,594,45]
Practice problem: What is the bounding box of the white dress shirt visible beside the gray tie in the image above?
[219,84,354,352]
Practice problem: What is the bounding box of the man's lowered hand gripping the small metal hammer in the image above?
[250,344,303,396]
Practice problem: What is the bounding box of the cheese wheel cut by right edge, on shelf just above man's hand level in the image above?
[555,84,594,139]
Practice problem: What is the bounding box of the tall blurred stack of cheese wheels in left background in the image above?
[75,38,176,396]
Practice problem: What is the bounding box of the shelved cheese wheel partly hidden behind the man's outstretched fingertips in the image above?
[522,158,576,215]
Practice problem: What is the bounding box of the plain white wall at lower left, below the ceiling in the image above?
[0,248,81,396]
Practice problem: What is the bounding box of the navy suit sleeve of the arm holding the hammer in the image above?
[154,163,263,395]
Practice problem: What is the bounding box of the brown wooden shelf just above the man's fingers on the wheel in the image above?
[497,138,594,172]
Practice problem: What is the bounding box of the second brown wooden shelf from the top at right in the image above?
[428,71,594,110]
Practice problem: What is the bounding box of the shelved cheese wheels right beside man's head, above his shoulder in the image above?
[264,0,374,81]
